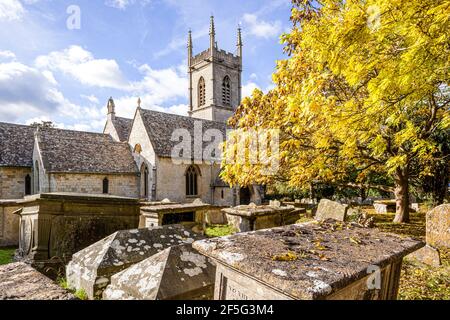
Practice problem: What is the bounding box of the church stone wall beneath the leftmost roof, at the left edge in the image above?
[0,167,32,199]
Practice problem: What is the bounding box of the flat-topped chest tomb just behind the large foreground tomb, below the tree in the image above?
[222,202,300,232]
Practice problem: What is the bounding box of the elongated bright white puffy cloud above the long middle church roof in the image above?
[35,45,127,90]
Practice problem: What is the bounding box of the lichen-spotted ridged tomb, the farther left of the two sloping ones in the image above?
[66,225,202,299]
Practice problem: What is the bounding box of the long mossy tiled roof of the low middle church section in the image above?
[38,128,138,174]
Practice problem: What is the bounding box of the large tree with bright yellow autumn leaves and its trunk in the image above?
[222,0,450,222]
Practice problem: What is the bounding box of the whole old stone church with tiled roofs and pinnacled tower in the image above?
[0,18,261,206]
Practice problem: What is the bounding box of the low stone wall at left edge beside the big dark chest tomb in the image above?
[0,200,21,247]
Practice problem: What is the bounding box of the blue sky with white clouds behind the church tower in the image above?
[0,0,291,131]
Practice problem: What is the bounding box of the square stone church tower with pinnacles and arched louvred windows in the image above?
[188,17,243,122]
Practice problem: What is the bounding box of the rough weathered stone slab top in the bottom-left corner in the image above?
[0,262,75,300]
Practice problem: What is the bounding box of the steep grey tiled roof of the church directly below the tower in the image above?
[139,109,226,157]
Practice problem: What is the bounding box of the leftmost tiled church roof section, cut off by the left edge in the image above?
[0,122,36,167]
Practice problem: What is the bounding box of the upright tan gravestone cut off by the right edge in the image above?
[427,204,450,248]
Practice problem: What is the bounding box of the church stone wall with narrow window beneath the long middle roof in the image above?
[41,173,139,198]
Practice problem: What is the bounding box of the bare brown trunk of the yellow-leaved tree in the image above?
[394,169,409,223]
